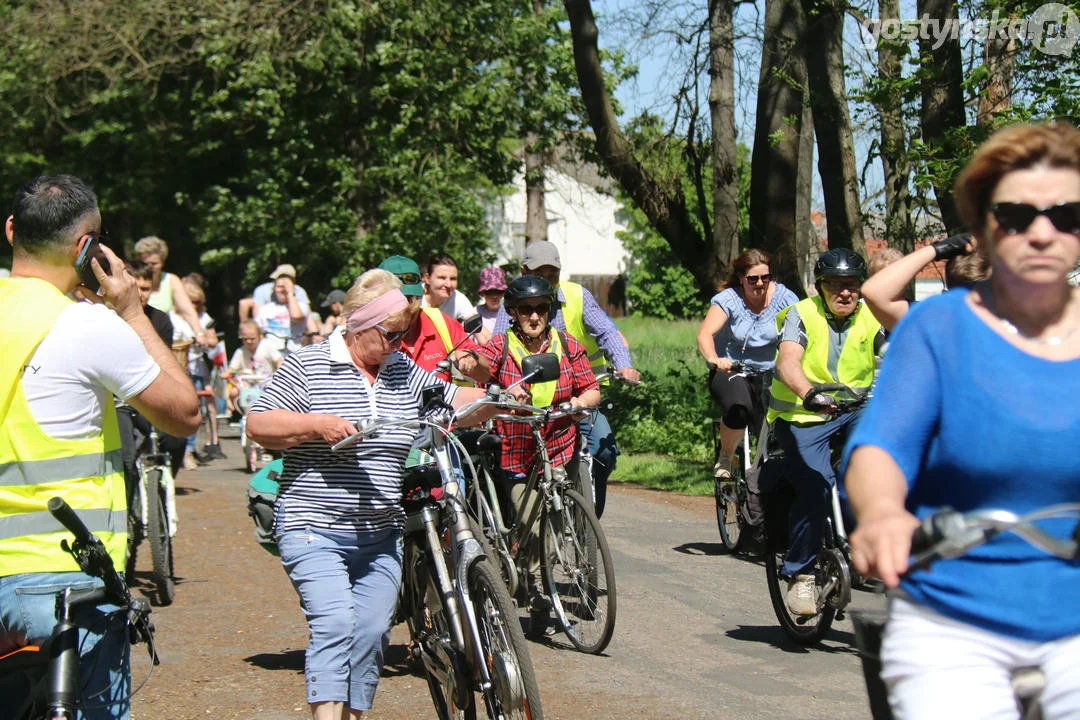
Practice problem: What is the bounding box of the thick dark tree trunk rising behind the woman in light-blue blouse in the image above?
[750,0,806,288]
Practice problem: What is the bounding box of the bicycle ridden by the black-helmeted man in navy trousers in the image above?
[765,383,869,646]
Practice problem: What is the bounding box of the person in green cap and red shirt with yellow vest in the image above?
[379,255,490,384]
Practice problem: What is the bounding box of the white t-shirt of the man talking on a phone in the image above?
[23,302,161,439]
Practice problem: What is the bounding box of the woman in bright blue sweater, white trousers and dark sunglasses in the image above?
[845,123,1080,720]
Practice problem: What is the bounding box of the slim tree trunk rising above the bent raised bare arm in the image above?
[874,0,915,255]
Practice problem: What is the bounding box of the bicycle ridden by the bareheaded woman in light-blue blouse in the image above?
[713,363,782,553]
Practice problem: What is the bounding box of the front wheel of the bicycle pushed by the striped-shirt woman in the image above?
[469,558,543,720]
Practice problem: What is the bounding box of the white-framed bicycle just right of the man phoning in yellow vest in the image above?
[124,425,179,606]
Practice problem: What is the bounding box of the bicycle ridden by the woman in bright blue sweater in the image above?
[851,503,1080,720]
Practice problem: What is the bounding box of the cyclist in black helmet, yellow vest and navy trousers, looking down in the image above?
[768,248,885,615]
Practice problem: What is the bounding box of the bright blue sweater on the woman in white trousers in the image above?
[845,289,1080,642]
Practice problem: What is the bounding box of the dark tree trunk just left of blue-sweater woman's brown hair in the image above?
[916,0,966,234]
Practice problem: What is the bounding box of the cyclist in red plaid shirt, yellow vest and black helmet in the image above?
[481,275,600,635]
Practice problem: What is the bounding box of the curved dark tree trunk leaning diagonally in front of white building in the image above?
[564,0,720,293]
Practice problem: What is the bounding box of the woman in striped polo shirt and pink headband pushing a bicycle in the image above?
[247,270,484,720]
